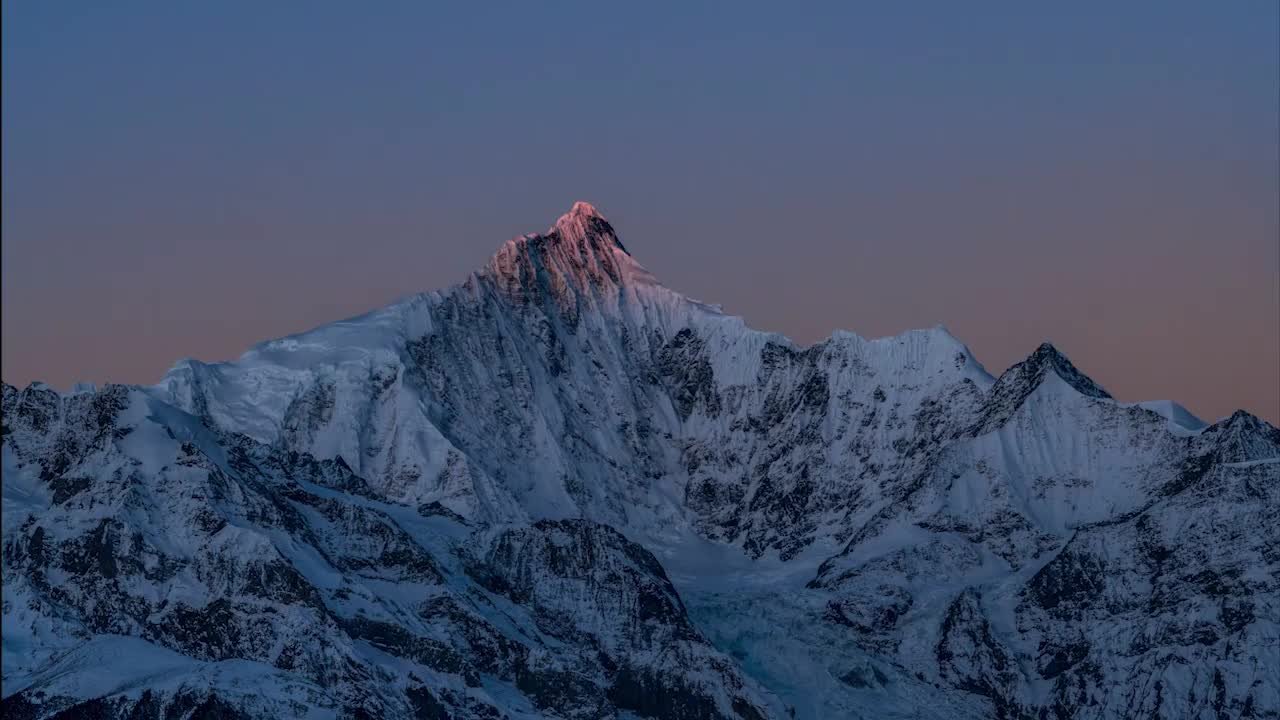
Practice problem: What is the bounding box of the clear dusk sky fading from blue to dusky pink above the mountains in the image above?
[0,0,1280,423]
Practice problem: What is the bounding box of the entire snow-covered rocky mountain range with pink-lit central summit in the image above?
[3,202,1280,720]
